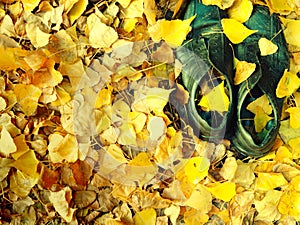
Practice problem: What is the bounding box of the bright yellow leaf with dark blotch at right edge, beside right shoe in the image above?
[276,70,300,98]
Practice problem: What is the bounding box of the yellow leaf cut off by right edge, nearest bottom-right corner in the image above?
[278,191,300,220]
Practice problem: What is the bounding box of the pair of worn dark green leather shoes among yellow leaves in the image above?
[176,0,289,157]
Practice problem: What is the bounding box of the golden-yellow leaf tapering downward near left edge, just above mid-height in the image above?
[14,84,42,116]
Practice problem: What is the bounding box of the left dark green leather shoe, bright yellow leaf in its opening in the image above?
[176,0,234,141]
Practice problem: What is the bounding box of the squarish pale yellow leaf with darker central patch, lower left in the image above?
[48,133,78,163]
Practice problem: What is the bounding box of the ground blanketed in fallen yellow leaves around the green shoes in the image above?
[0,0,300,225]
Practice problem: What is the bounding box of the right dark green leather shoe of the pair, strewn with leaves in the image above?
[232,6,289,157]
